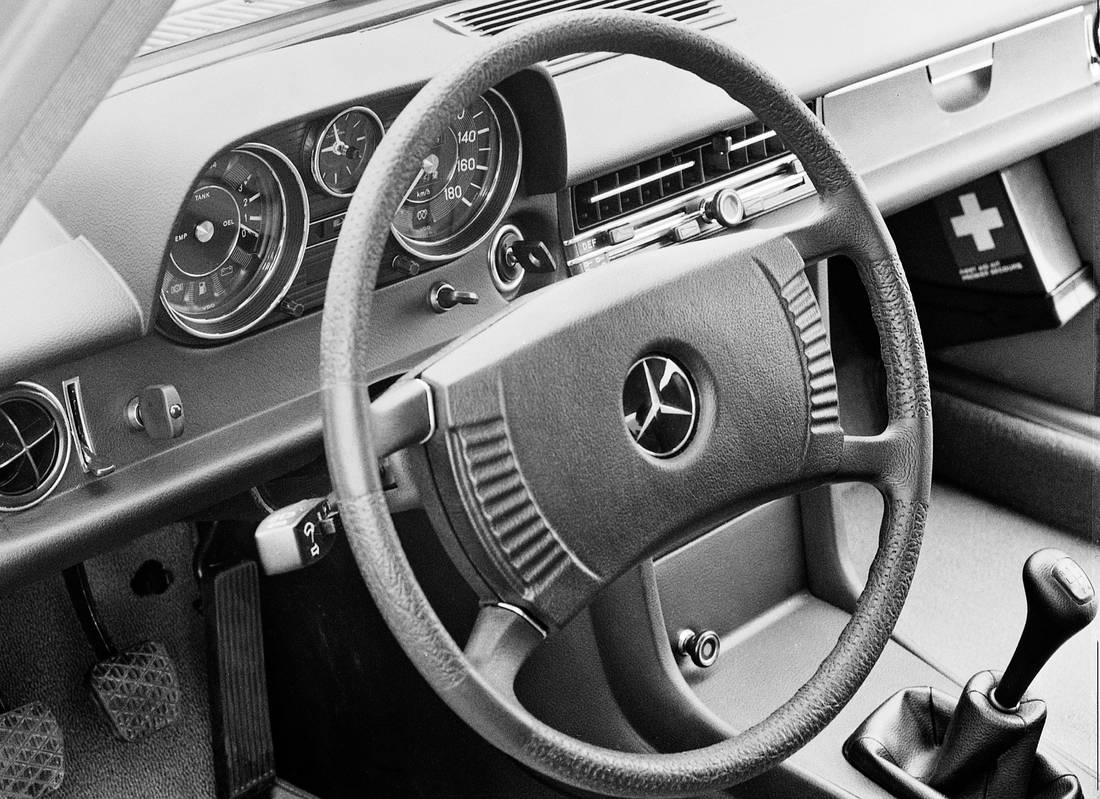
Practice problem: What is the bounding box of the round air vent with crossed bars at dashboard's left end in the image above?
[0,383,69,511]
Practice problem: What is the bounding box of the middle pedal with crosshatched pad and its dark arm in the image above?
[64,563,179,742]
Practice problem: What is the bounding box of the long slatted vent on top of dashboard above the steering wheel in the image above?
[438,0,734,75]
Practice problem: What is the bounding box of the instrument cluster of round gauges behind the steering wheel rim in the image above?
[161,90,523,340]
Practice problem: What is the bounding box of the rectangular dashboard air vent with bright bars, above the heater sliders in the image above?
[572,122,789,231]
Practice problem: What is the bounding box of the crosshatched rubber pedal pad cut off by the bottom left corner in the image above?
[0,702,65,799]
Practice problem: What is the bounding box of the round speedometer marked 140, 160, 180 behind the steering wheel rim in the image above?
[393,91,521,260]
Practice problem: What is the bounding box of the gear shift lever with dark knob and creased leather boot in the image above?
[844,549,1097,799]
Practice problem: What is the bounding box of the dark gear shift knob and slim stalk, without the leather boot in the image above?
[991,549,1097,710]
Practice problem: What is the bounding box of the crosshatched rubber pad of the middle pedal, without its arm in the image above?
[88,641,179,742]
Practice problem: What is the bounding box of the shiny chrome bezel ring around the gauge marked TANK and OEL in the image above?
[161,142,309,341]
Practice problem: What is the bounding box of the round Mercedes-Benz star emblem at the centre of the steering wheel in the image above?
[623,355,699,458]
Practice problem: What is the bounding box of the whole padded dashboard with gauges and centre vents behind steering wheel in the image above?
[0,0,1100,580]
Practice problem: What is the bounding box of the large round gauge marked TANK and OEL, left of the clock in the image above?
[161,144,307,339]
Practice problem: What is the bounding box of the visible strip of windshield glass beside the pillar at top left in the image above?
[138,0,329,56]
